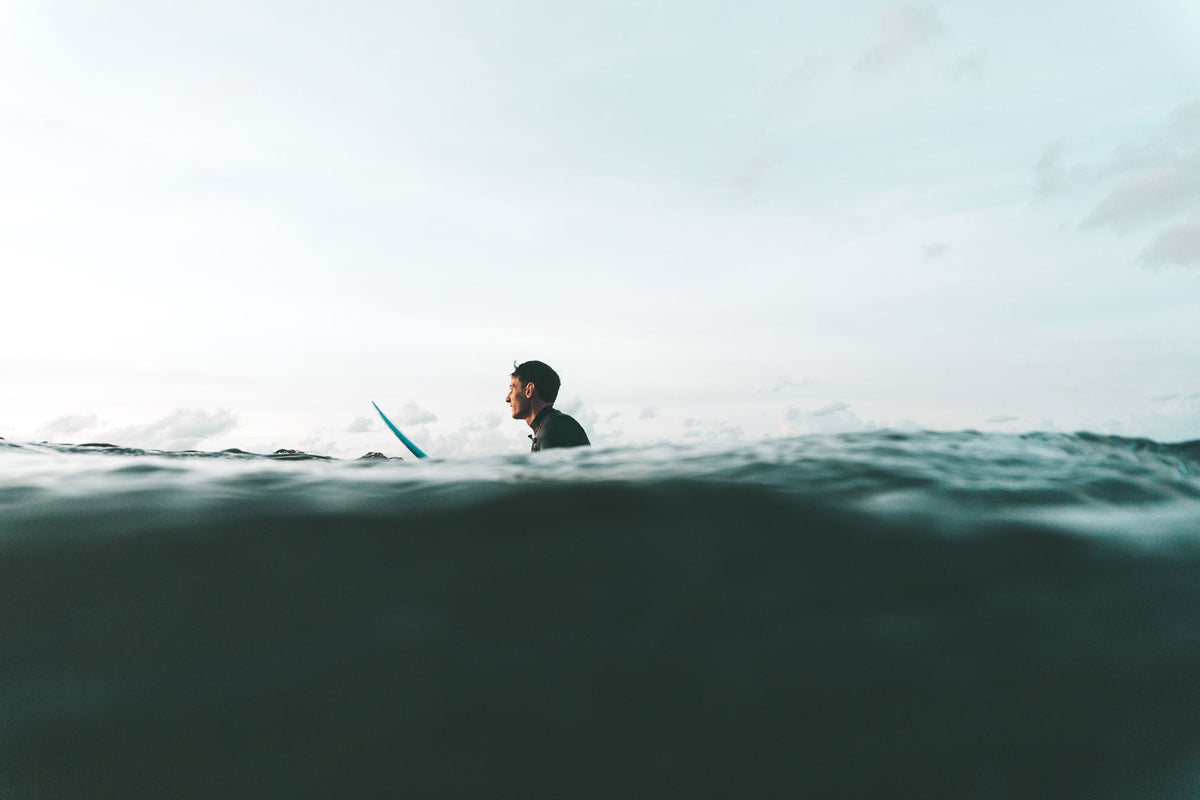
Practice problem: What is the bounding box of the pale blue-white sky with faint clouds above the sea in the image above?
[0,0,1200,458]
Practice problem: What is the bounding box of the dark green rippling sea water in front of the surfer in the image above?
[0,433,1200,800]
